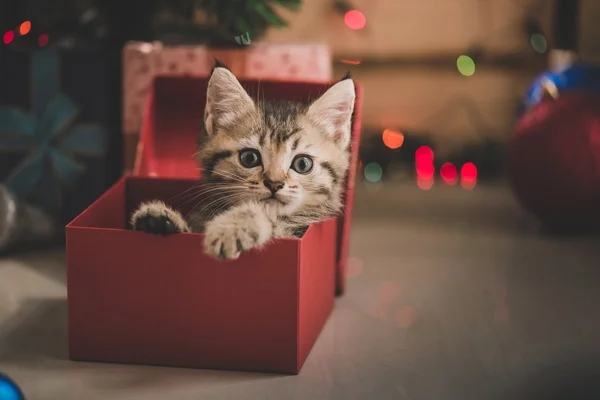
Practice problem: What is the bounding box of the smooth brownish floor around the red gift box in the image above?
[0,184,600,400]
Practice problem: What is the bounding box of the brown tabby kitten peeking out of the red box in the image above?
[131,62,355,259]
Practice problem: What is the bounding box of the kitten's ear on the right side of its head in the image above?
[307,76,356,148]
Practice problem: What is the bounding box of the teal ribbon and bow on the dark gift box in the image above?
[0,49,106,212]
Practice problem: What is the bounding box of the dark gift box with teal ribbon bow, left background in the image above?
[0,48,118,225]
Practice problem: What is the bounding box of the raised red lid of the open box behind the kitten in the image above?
[133,77,362,292]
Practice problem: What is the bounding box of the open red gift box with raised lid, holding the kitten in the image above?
[66,77,361,374]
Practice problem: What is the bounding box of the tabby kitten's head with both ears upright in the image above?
[199,64,355,217]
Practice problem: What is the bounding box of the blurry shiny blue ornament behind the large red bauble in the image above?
[517,63,600,117]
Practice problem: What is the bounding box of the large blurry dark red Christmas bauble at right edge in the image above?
[508,91,600,229]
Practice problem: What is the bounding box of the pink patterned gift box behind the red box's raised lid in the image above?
[123,42,331,170]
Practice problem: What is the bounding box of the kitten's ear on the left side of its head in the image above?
[204,60,256,135]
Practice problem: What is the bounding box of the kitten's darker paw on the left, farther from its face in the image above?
[131,201,190,235]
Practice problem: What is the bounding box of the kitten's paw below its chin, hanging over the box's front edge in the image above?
[204,213,270,260]
